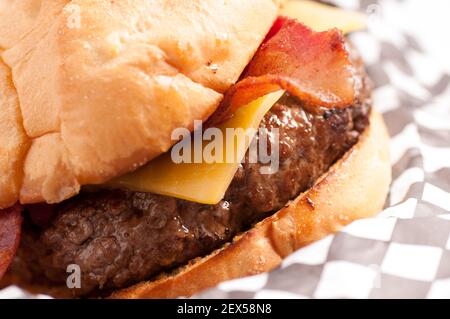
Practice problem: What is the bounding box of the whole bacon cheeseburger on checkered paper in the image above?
[0,0,390,298]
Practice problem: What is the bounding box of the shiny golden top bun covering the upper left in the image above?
[0,0,280,207]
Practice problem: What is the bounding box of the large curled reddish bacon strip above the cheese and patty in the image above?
[214,17,355,122]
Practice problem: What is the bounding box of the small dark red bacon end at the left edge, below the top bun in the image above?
[0,205,22,279]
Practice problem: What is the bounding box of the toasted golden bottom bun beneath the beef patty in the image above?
[112,112,391,298]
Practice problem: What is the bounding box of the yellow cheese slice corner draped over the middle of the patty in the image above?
[110,90,284,204]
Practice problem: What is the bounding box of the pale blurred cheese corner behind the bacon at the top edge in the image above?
[280,0,367,34]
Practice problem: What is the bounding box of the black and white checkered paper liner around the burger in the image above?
[0,0,450,298]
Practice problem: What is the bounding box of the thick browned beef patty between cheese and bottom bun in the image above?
[15,54,370,295]
